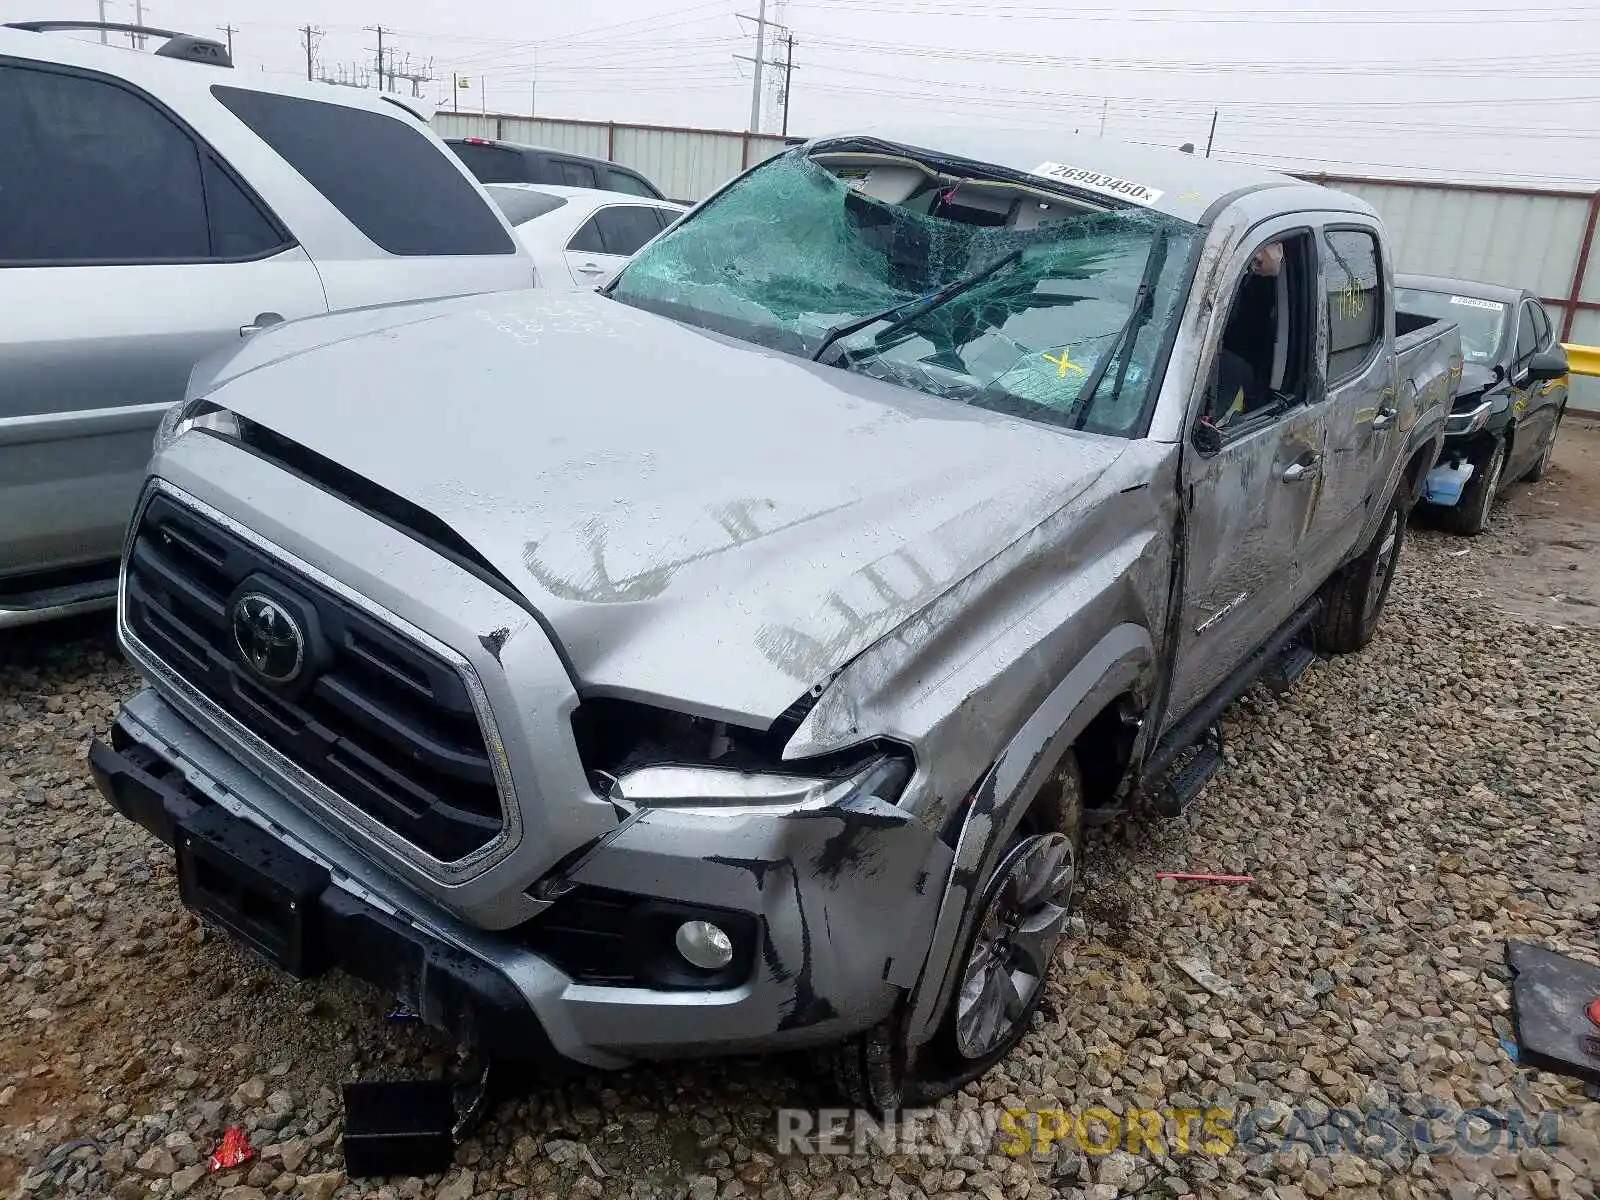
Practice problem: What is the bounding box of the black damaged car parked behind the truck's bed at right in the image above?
[1395,275,1568,536]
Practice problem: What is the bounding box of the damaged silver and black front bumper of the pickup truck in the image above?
[91,690,952,1069]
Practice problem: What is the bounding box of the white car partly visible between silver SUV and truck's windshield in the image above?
[483,184,688,291]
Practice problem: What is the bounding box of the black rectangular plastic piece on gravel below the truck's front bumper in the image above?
[344,1080,456,1178]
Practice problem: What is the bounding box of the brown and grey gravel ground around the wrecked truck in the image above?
[9,438,1600,1200]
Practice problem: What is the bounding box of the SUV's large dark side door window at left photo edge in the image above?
[0,66,213,264]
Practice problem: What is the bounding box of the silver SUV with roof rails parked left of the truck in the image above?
[0,22,533,627]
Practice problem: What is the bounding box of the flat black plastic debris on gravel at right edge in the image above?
[1506,941,1600,1083]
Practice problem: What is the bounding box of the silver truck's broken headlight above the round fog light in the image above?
[610,758,910,814]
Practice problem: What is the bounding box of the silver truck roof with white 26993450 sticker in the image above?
[808,125,1373,222]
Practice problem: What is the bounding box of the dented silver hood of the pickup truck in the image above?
[210,291,1122,725]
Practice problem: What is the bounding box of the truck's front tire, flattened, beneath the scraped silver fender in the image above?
[830,750,1083,1114]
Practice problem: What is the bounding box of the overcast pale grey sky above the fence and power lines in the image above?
[12,0,1600,186]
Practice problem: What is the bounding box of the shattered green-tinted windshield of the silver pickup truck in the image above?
[610,150,1194,435]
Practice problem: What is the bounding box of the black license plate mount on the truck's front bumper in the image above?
[176,805,328,979]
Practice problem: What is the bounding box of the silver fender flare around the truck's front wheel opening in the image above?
[906,624,1155,1045]
